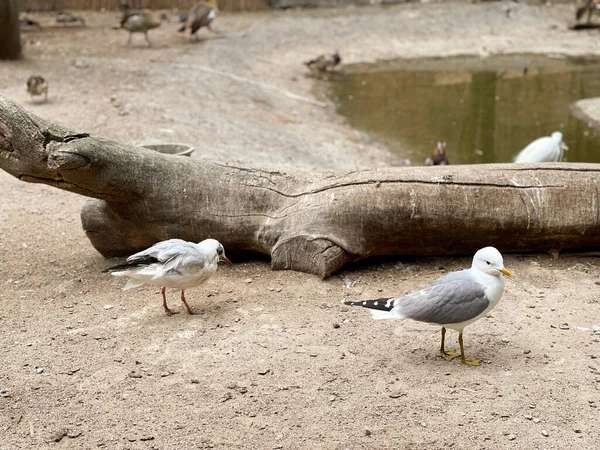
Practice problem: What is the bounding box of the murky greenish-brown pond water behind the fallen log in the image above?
[328,55,600,165]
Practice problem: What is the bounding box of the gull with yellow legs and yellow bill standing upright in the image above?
[344,247,512,366]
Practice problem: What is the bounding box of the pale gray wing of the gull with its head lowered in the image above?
[127,239,206,271]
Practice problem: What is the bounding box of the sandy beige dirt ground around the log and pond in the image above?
[0,2,600,450]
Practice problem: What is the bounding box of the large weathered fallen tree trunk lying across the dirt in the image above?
[0,97,600,277]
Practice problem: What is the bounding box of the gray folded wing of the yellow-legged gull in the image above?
[394,271,490,324]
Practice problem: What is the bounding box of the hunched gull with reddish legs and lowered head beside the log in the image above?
[104,239,231,315]
